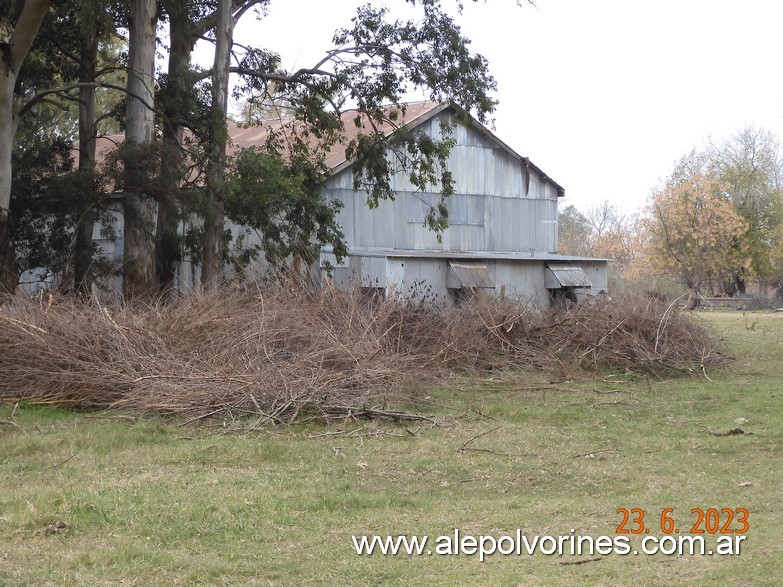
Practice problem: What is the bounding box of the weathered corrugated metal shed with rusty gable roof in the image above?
[81,102,607,305]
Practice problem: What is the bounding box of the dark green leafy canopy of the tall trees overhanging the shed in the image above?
[0,0,502,297]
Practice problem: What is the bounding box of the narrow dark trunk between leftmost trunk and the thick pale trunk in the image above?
[73,3,98,296]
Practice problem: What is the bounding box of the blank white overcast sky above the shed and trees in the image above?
[193,0,783,212]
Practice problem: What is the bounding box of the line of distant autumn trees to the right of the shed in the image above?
[559,128,783,306]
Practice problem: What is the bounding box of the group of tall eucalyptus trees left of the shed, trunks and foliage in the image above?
[0,0,502,299]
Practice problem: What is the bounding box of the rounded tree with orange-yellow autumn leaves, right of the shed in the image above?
[635,173,748,308]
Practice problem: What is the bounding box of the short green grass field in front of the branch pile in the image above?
[0,312,783,586]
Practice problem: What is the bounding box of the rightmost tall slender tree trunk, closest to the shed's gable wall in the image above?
[201,0,234,289]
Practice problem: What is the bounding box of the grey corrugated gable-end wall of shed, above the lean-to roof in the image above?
[326,114,557,253]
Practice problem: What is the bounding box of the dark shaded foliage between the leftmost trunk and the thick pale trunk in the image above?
[0,1,123,287]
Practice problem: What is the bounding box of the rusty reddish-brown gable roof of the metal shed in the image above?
[82,101,565,197]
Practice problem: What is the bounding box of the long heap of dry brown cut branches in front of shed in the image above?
[0,285,719,423]
